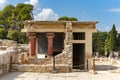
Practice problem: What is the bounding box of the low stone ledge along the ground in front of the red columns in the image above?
[11,64,70,73]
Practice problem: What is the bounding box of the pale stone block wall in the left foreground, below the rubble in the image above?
[0,51,17,75]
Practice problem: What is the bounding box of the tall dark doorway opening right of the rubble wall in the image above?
[73,43,85,70]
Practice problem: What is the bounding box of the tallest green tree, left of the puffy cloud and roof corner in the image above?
[10,3,33,30]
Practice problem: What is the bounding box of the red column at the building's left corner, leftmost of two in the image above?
[28,34,36,57]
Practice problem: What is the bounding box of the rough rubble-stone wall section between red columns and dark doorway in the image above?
[45,22,73,69]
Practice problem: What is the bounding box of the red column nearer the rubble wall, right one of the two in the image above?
[46,33,54,56]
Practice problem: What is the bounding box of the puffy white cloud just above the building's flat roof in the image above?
[34,9,58,21]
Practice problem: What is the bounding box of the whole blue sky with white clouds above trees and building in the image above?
[0,0,120,32]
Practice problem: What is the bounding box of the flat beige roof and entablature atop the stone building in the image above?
[22,20,98,32]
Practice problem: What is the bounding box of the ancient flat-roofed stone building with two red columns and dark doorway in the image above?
[22,21,97,70]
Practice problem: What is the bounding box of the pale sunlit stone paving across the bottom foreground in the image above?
[0,71,120,80]
